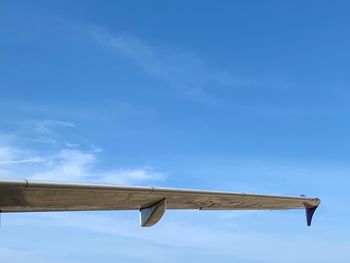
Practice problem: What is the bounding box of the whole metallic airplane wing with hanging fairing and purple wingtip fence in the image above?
[0,179,320,226]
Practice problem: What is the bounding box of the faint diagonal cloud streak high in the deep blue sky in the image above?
[92,27,250,103]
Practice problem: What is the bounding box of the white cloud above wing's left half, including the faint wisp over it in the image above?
[0,120,166,187]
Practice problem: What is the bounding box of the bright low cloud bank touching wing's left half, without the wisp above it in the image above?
[0,146,166,184]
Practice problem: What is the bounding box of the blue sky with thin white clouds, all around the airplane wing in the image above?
[0,1,350,263]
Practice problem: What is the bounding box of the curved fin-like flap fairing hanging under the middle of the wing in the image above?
[140,198,166,227]
